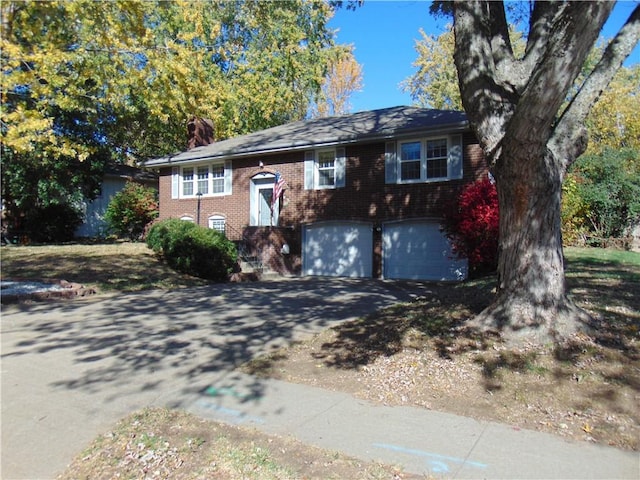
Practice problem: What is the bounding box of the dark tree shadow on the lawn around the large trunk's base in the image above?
[314,260,640,384]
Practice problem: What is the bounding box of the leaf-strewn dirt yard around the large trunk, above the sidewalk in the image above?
[243,279,640,450]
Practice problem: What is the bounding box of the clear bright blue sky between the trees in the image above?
[329,0,640,112]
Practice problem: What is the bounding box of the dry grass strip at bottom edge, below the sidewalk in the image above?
[58,409,424,480]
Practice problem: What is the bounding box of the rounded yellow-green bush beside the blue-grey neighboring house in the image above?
[104,182,159,240]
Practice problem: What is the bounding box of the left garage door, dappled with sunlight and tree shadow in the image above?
[302,222,373,277]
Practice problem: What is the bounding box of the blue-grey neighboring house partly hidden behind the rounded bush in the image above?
[74,165,158,238]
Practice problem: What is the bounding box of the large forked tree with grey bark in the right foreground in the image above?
[440,1,640,342]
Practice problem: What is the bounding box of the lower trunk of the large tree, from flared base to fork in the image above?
[472,145,590,343]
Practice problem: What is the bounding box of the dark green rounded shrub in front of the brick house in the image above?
[147,219,237,282]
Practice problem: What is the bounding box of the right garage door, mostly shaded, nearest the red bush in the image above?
[382,221,467,280]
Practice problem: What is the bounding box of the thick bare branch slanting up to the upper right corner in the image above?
[549,5,640,168]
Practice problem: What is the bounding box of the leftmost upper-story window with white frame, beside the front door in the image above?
[171,161,231,198]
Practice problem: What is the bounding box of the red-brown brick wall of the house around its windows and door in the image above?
[159,133,487,276]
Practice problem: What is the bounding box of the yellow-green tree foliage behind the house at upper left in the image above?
[0,0,336,232]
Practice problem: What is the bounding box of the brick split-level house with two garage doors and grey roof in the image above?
[146,107,487,280]
